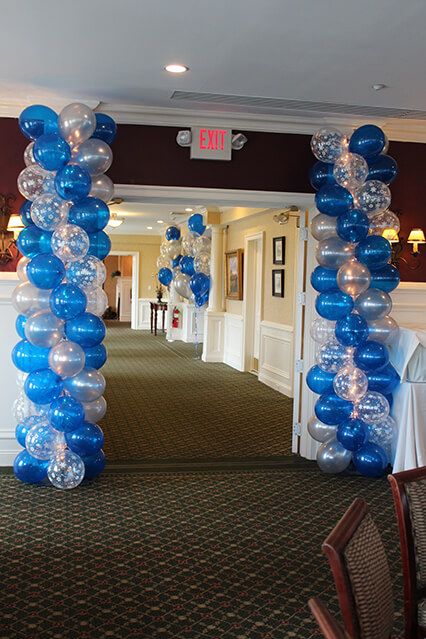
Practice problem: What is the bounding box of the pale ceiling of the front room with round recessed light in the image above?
[0,0,426,119]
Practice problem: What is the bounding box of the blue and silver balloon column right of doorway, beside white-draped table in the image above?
[306,125,399,477]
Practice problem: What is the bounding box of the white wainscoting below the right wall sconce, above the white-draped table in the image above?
[391,282,426,326]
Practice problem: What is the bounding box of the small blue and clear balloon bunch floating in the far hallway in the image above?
[157,213,211,308]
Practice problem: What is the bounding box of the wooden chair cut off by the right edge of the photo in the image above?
[388,467,426,639]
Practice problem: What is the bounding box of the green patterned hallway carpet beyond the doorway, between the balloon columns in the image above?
[101,323,292,461]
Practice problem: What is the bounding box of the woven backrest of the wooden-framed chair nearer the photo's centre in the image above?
[322,498,394,639]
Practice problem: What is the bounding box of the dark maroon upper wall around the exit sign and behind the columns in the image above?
[0,118,426,281]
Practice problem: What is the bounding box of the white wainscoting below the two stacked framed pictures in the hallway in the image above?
[259,321,294,397]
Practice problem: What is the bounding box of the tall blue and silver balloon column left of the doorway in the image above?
[12,103,116,489]
